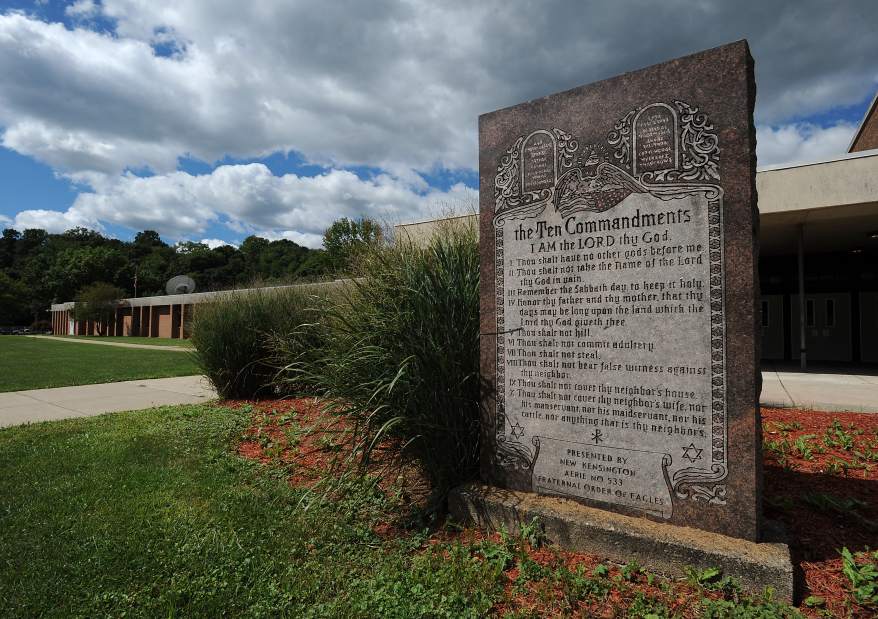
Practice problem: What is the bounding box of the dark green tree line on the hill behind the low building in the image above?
[0,218,382,326]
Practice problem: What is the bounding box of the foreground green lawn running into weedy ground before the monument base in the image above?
[0,405,801,619]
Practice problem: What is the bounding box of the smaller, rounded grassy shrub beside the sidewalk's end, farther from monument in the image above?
[191,286,324,399]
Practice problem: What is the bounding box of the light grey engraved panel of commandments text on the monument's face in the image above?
[497,168,724,516]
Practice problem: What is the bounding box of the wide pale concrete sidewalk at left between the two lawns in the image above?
[0,376,216,428]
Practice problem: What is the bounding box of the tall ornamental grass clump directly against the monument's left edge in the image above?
[285,227,479,514]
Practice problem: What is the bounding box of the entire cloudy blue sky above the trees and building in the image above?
[0,0,878,247]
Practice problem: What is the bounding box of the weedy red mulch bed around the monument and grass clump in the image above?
[227,399,878,618]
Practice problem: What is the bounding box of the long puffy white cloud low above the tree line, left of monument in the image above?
[8,163,478,247]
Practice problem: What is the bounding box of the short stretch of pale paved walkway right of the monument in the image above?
[760,370,878,413]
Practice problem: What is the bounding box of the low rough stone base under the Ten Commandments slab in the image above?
[448,483,793,603]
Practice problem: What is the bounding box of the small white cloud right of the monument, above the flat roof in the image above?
[756,123,856,166]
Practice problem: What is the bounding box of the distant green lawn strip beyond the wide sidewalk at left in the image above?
[0,335,200,392]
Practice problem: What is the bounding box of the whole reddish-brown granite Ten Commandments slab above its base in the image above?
[479,42,761,539]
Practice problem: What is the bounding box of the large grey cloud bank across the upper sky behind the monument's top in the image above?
[0,0,878,179]
